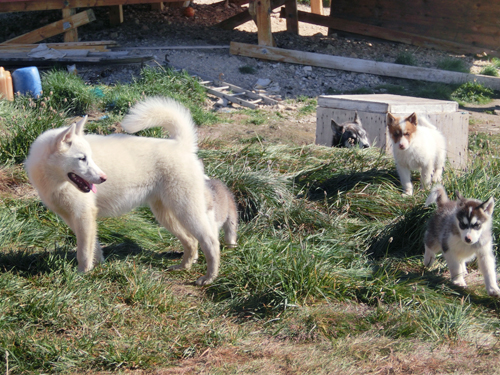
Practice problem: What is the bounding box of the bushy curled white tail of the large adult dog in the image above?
[121,97,198,152]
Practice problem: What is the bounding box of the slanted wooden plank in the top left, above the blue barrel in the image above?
[2,9,95,44]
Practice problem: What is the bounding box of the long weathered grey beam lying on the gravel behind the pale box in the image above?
[229,42,500,90]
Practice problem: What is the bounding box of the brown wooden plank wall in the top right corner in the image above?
[331,0,500,50]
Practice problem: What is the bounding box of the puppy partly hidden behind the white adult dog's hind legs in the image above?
[205,176,238,247]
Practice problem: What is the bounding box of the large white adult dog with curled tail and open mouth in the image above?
[25,98,220,285]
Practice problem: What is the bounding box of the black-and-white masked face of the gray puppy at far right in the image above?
[455,198,494,245]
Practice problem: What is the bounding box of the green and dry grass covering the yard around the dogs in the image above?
[0,70,500,374]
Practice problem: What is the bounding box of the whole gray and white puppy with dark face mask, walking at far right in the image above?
[424,185,500,297]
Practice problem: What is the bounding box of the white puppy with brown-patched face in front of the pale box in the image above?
[387,113,446,195]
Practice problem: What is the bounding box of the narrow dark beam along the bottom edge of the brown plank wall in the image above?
[280,9,500,56]
